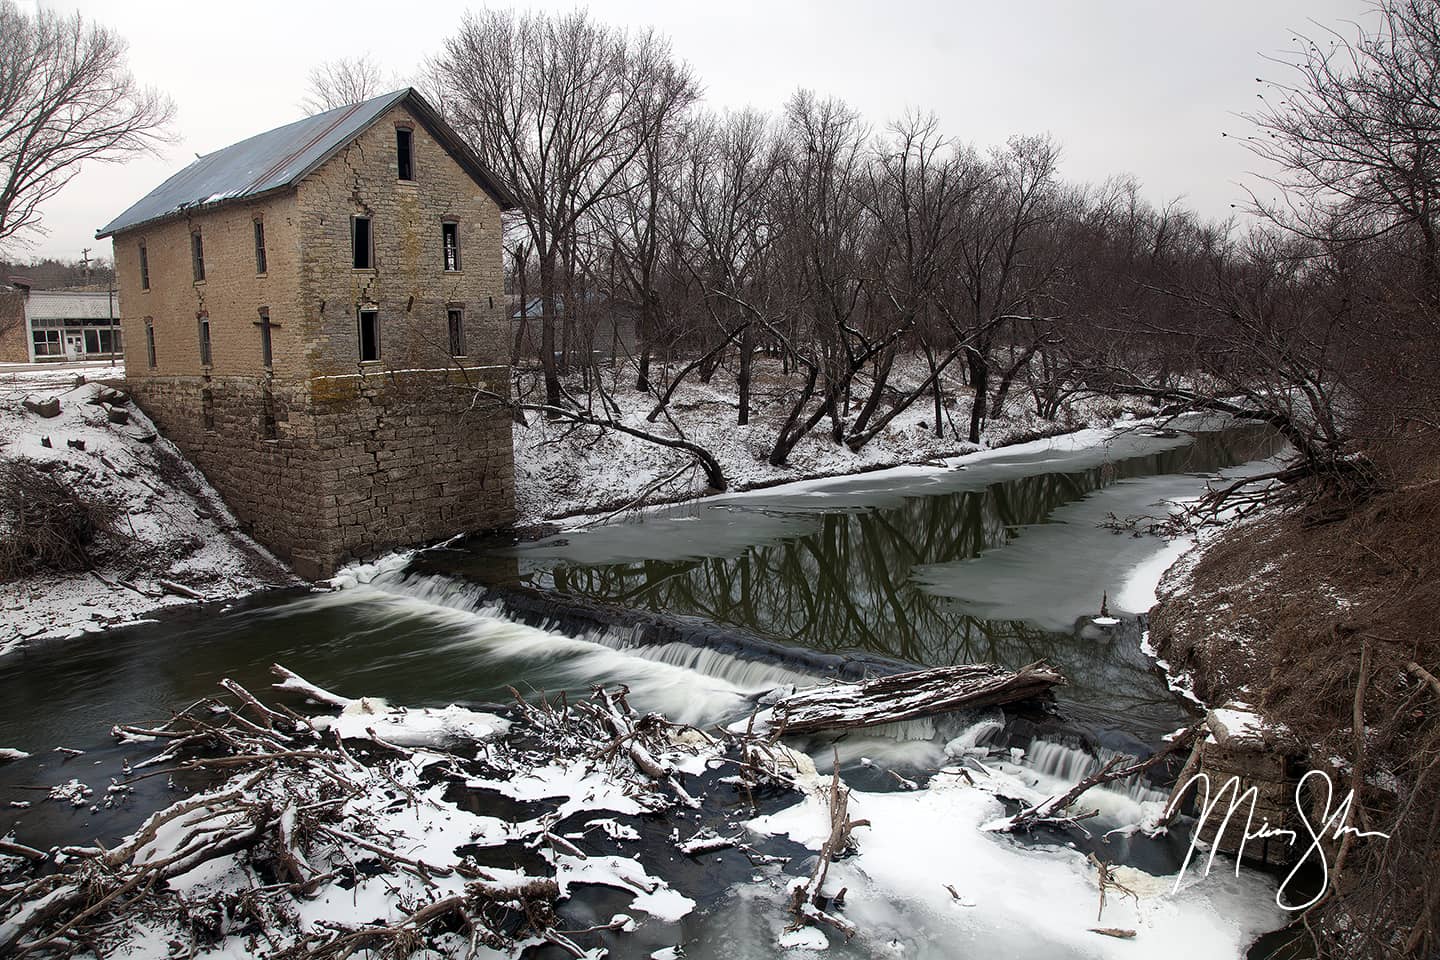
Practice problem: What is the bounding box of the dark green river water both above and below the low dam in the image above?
[0,414,1277,846]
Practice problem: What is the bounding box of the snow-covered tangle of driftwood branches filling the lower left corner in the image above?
[0,666,760,960]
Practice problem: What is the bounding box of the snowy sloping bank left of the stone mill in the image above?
[0,366,292,655]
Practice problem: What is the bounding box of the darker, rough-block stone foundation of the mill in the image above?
[130,367,514,579]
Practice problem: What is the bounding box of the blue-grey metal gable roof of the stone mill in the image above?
[95,86,516,239]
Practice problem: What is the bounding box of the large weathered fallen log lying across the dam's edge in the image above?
[770,662,1066,734]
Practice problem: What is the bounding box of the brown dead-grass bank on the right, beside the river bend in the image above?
[1152,460,1440,957]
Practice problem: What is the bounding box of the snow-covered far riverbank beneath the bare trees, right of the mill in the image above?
[514,357,1151,522]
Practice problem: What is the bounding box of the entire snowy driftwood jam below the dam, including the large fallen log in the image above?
[0,664,1082,960]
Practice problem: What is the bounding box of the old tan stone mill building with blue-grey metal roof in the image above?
[96,89,514,577]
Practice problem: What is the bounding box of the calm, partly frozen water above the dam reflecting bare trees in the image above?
[452,427,1279,737]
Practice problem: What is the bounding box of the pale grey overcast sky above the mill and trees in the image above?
[16,0,1369,258]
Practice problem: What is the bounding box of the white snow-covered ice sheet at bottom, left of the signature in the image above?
[750,759,1284,960]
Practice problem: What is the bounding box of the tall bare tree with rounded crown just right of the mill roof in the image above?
[431,10,698,410]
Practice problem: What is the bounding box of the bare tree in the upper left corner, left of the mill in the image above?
[0,0,174,246]
